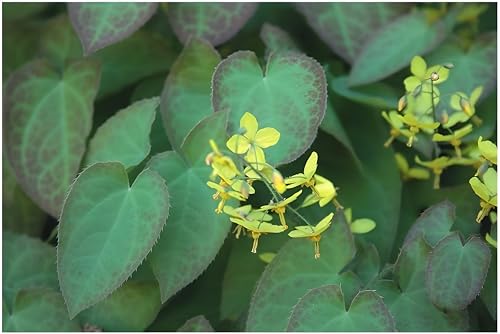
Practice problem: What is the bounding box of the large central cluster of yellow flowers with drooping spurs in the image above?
[205,112,375,259]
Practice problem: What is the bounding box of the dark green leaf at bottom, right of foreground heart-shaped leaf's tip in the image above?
[78,280,161,332]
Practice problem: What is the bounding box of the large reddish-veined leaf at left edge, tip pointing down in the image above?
[4,60,100,217]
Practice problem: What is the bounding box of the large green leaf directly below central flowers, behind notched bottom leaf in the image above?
[246,212,359,332]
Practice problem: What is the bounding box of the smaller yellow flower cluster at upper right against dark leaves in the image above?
[382,56,483,189]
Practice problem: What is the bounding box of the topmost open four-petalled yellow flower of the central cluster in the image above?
[226,112,280,167]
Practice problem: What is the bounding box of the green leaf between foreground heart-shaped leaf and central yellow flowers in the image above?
[148,113,230,302]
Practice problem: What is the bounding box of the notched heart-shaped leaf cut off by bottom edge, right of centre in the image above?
[287,285,396,332]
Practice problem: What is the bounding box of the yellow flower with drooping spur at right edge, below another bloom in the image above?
[469,168,497,223]
